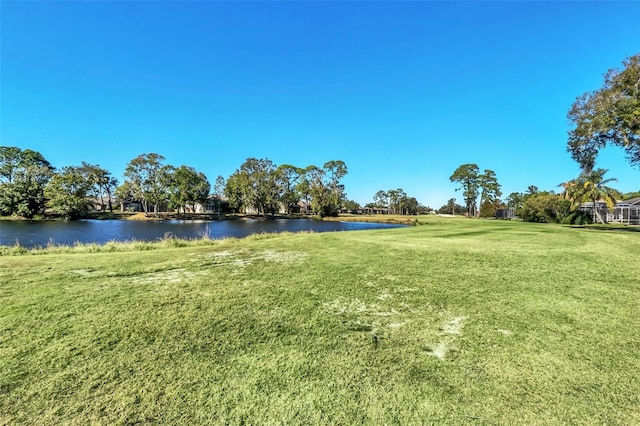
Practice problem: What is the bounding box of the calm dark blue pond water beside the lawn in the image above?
[0,219,403,247]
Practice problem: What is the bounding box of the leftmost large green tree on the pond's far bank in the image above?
[0,146,54,218]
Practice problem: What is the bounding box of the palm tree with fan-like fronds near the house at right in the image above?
[560,169,620,223]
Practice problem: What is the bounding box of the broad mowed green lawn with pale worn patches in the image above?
[0,217,640,425]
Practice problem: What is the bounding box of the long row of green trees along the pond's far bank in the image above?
[0,146,357,219]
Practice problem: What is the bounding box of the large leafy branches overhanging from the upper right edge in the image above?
[568,54,640,171]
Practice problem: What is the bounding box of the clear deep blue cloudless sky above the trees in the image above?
[0,0,640,208]
